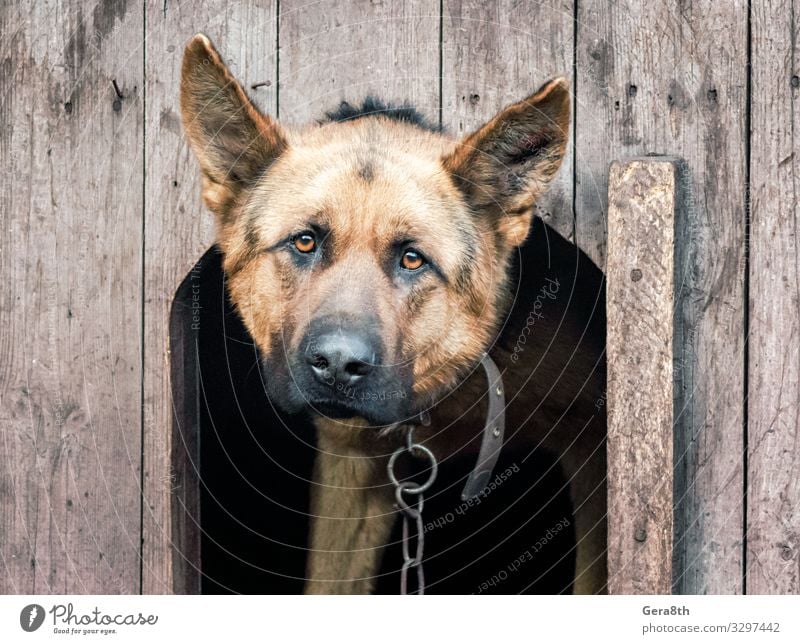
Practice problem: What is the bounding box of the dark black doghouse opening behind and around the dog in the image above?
[170,220,602,594]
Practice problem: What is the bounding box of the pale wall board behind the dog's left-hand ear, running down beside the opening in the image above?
[142,0,277,593]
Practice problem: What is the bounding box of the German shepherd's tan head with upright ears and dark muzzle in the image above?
[181,35,570,425]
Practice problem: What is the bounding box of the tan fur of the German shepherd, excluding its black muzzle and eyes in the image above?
[181,35,605,593]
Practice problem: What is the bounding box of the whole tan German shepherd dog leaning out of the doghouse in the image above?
[181,34,606,593]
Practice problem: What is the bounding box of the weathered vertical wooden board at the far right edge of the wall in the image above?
[745,0,800,594]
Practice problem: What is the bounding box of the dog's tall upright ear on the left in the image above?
[181,34,287,223]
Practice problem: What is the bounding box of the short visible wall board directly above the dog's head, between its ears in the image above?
[279,0,439,124]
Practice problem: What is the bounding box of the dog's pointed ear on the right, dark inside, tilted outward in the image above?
[442,78,570,246]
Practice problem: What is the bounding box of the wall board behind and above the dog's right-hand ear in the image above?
[442,0,576,244]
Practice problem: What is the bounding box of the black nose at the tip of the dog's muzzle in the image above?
[306,329,376,385]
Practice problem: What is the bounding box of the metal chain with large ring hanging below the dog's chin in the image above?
[386,427,439,595]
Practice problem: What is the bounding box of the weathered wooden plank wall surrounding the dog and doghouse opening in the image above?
[0,0,800,593]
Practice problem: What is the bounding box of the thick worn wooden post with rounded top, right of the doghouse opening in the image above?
[606,157,687,594]
